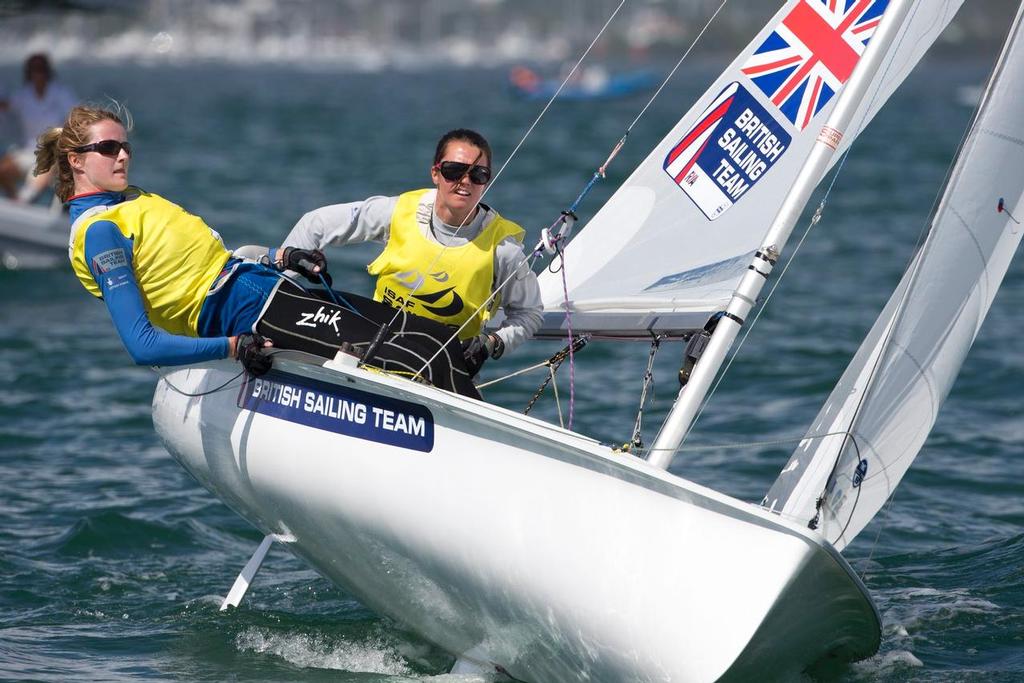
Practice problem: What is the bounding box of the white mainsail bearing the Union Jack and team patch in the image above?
[540,0,963,337]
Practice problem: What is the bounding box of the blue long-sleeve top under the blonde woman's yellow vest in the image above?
[69,193,230,366]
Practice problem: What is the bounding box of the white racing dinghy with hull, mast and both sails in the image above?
[154,0,1024,681]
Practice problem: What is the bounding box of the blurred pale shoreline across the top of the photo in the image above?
[0,0,1015,72]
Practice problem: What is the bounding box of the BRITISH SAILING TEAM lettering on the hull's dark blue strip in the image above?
[250,379,426,436]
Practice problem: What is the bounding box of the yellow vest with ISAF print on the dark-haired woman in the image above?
[367,189,525,339]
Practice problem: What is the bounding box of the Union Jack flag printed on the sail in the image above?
[741,0,889,130]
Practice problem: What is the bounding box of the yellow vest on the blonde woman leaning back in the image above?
[69,187,231,337]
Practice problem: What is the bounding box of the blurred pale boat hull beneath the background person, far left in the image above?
[0,199,69,269]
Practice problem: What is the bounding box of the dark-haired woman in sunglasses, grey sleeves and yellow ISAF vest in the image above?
[284,128,543,375]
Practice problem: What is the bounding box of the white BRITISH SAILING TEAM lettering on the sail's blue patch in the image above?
[712,109,786,200]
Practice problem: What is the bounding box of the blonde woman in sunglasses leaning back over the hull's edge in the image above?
[41,105,478,395]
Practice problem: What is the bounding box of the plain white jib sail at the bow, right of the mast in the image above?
[764,2,1024,550]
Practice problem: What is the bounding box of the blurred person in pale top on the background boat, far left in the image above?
[0,53,77,203]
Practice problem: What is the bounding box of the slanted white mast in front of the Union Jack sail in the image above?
[647,0,912,469]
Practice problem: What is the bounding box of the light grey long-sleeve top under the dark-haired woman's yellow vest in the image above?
[283,191,543,351]
